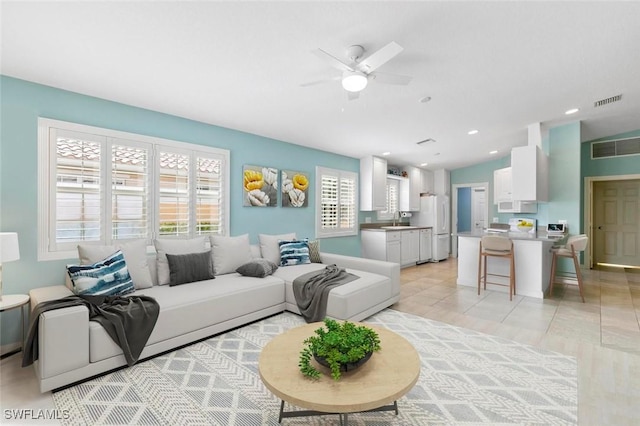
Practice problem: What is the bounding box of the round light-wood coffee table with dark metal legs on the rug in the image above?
[258,322,420,424]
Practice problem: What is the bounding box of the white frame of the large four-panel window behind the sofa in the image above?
[37,117,231,261]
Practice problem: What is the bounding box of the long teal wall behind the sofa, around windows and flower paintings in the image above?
[0,76,360,344]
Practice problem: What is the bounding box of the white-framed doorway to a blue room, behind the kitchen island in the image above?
[451,182,489,257]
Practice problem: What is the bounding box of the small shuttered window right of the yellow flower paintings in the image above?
[316,167,358,238]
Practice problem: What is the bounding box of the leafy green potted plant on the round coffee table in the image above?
[298,318,380,380]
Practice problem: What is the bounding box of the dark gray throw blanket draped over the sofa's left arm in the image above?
[22,295,160,367]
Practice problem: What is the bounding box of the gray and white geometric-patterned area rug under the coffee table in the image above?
[53,309,578,426]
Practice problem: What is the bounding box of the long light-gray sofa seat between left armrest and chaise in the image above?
[89,273,284,362]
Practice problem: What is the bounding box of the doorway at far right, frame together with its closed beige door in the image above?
[585,175,640,268]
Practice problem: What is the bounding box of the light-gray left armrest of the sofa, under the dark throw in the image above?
[29,286,89,379]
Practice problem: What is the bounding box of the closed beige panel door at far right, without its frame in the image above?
[593,180,640,266]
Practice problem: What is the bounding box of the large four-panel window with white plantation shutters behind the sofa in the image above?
[38,118,229,260]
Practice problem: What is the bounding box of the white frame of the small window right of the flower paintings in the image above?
[316,166,359,238]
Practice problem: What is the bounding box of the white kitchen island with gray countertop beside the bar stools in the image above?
[457,231,564,300]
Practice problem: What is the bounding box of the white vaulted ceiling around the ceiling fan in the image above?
[0,1,640,169]
